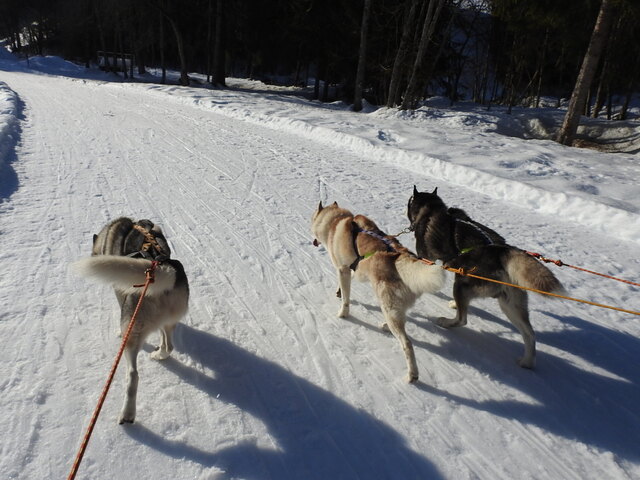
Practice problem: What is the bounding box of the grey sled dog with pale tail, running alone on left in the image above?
[73,217,189,424]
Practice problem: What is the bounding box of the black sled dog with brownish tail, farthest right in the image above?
[407,186,564,368]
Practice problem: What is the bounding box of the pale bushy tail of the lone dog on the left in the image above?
[72,255,177,296]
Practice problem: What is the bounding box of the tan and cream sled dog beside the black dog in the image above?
[311,202,444,383]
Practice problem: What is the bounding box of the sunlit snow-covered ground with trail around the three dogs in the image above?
[0,52,640,480]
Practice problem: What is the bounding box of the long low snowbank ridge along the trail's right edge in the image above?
[112,81,640,243]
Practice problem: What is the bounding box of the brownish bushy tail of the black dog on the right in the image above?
[505,248,565,295]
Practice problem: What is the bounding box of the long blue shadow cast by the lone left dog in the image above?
[126,324,443,480]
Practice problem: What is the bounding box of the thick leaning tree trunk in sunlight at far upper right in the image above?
[556,0,615,145]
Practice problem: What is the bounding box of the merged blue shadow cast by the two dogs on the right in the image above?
[413,311,640,462]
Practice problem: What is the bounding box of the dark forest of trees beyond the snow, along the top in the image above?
[0,0,640,117]
